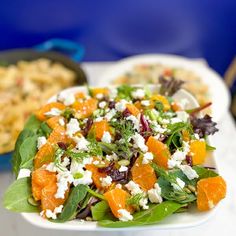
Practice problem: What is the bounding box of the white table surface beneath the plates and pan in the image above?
[0,63,236,236]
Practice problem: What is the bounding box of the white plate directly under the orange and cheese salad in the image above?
[21,86,218,231]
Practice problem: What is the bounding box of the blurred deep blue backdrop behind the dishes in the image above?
[0,0,236,74]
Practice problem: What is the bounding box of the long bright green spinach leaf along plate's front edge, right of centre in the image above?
[98,201,182,228]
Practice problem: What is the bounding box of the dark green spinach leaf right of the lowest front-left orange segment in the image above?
[53,185,87,223]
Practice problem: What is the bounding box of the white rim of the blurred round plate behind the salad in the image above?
[99,54,230,121]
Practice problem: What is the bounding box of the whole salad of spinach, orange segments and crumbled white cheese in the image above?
[3,80,226,227]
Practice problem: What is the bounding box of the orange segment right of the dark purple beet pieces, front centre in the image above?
[131,157,157,191]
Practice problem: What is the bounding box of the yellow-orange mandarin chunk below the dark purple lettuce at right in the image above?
[189,140,207,165]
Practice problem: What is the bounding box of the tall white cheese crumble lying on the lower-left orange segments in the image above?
[55,171,74,199]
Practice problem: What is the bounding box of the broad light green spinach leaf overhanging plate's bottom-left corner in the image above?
[3,177,38,212]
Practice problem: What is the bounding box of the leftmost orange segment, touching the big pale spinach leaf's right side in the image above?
[32,169,57,201]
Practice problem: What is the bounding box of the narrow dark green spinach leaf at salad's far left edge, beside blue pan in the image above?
[12,129,34,176]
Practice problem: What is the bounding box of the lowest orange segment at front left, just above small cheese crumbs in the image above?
[41,182,69,211]
